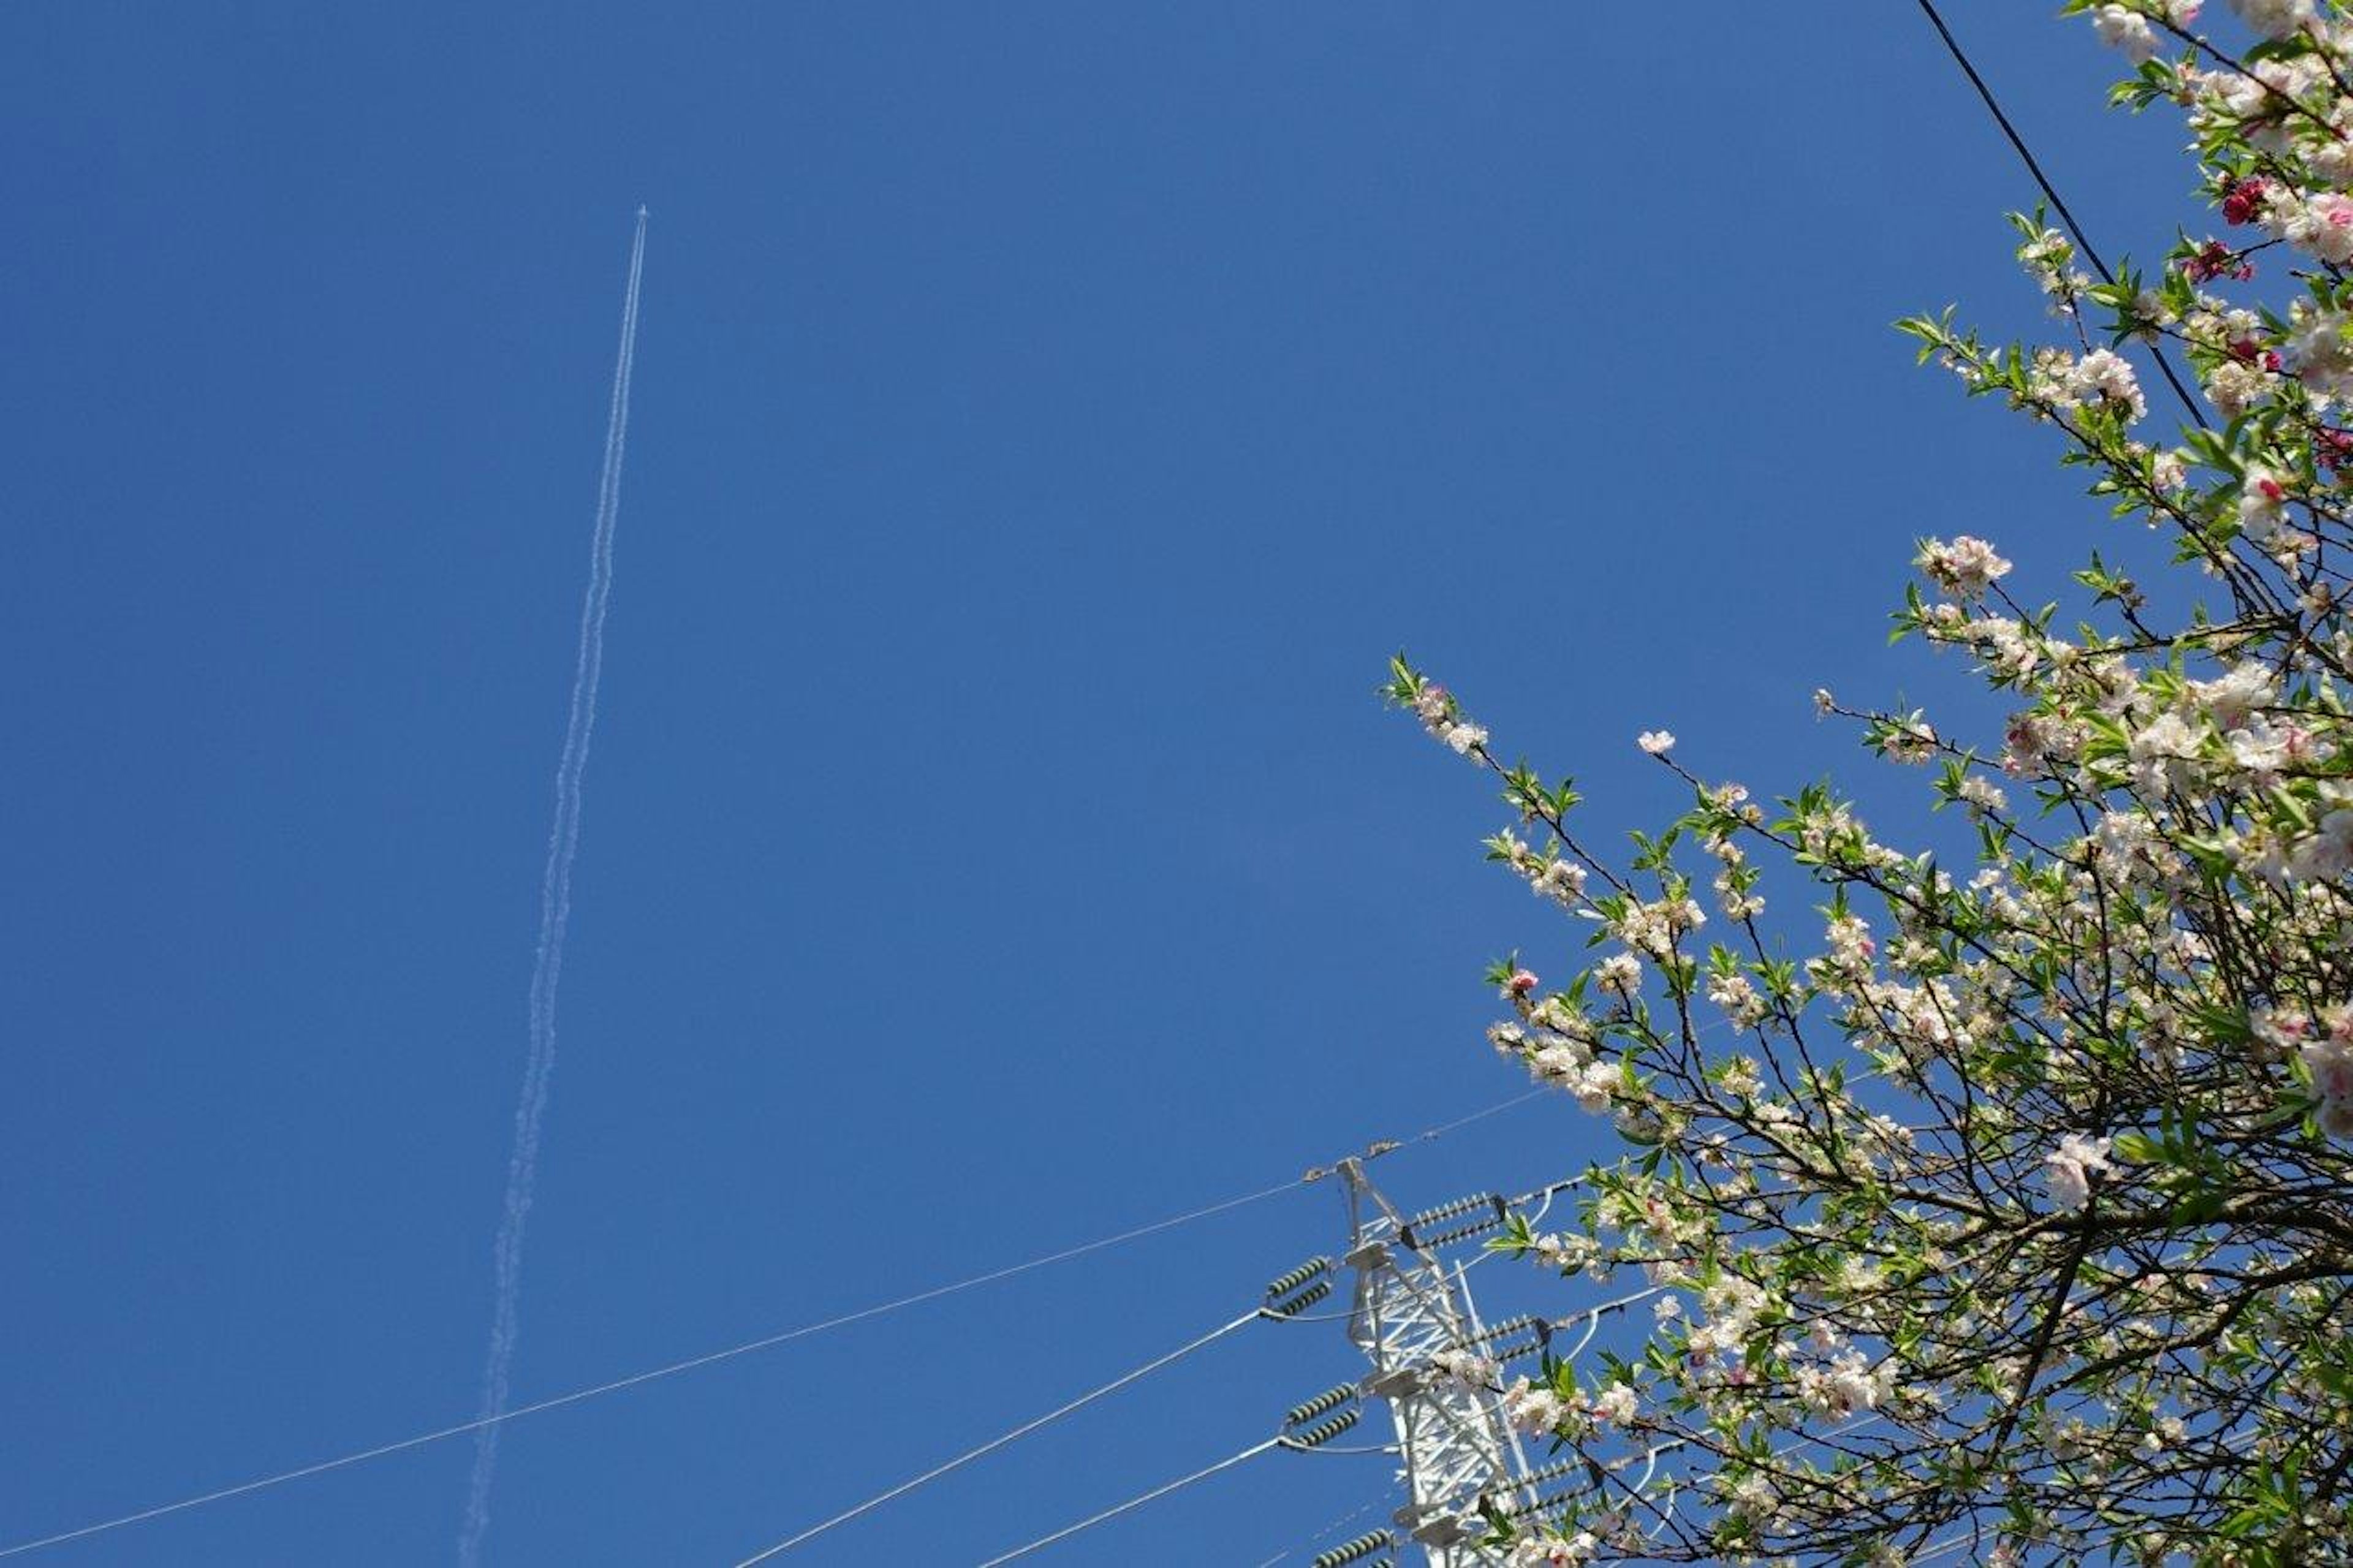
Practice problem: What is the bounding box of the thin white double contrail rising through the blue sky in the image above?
[457,207,645,1568]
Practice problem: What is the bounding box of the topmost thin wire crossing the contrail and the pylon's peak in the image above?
[0,1090,1541,1559]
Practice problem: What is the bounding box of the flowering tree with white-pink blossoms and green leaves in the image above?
[1389,0,2353,1568]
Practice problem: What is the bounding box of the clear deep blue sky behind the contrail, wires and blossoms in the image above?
[0,0,2186,1566]
